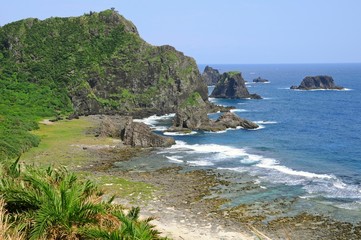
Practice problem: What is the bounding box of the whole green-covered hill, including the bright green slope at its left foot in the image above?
[0,9,197,158]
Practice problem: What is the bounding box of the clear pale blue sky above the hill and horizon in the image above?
[0,0,361,64]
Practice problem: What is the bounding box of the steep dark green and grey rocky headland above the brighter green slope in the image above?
[0,10,207,115]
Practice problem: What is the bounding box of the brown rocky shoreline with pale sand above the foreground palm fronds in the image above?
[80,135,361,239]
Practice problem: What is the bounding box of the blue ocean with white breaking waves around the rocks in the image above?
[114,64,361,222]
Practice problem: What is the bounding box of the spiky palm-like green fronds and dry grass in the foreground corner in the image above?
[0,159,165,240]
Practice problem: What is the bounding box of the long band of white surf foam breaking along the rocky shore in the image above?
[163,141,361,201]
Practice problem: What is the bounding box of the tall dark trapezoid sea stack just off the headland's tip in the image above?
[210,72,261,99]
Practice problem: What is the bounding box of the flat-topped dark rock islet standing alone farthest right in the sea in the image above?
[291,76,344,90]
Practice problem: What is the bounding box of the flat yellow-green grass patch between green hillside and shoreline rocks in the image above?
[21,117,114,168]
